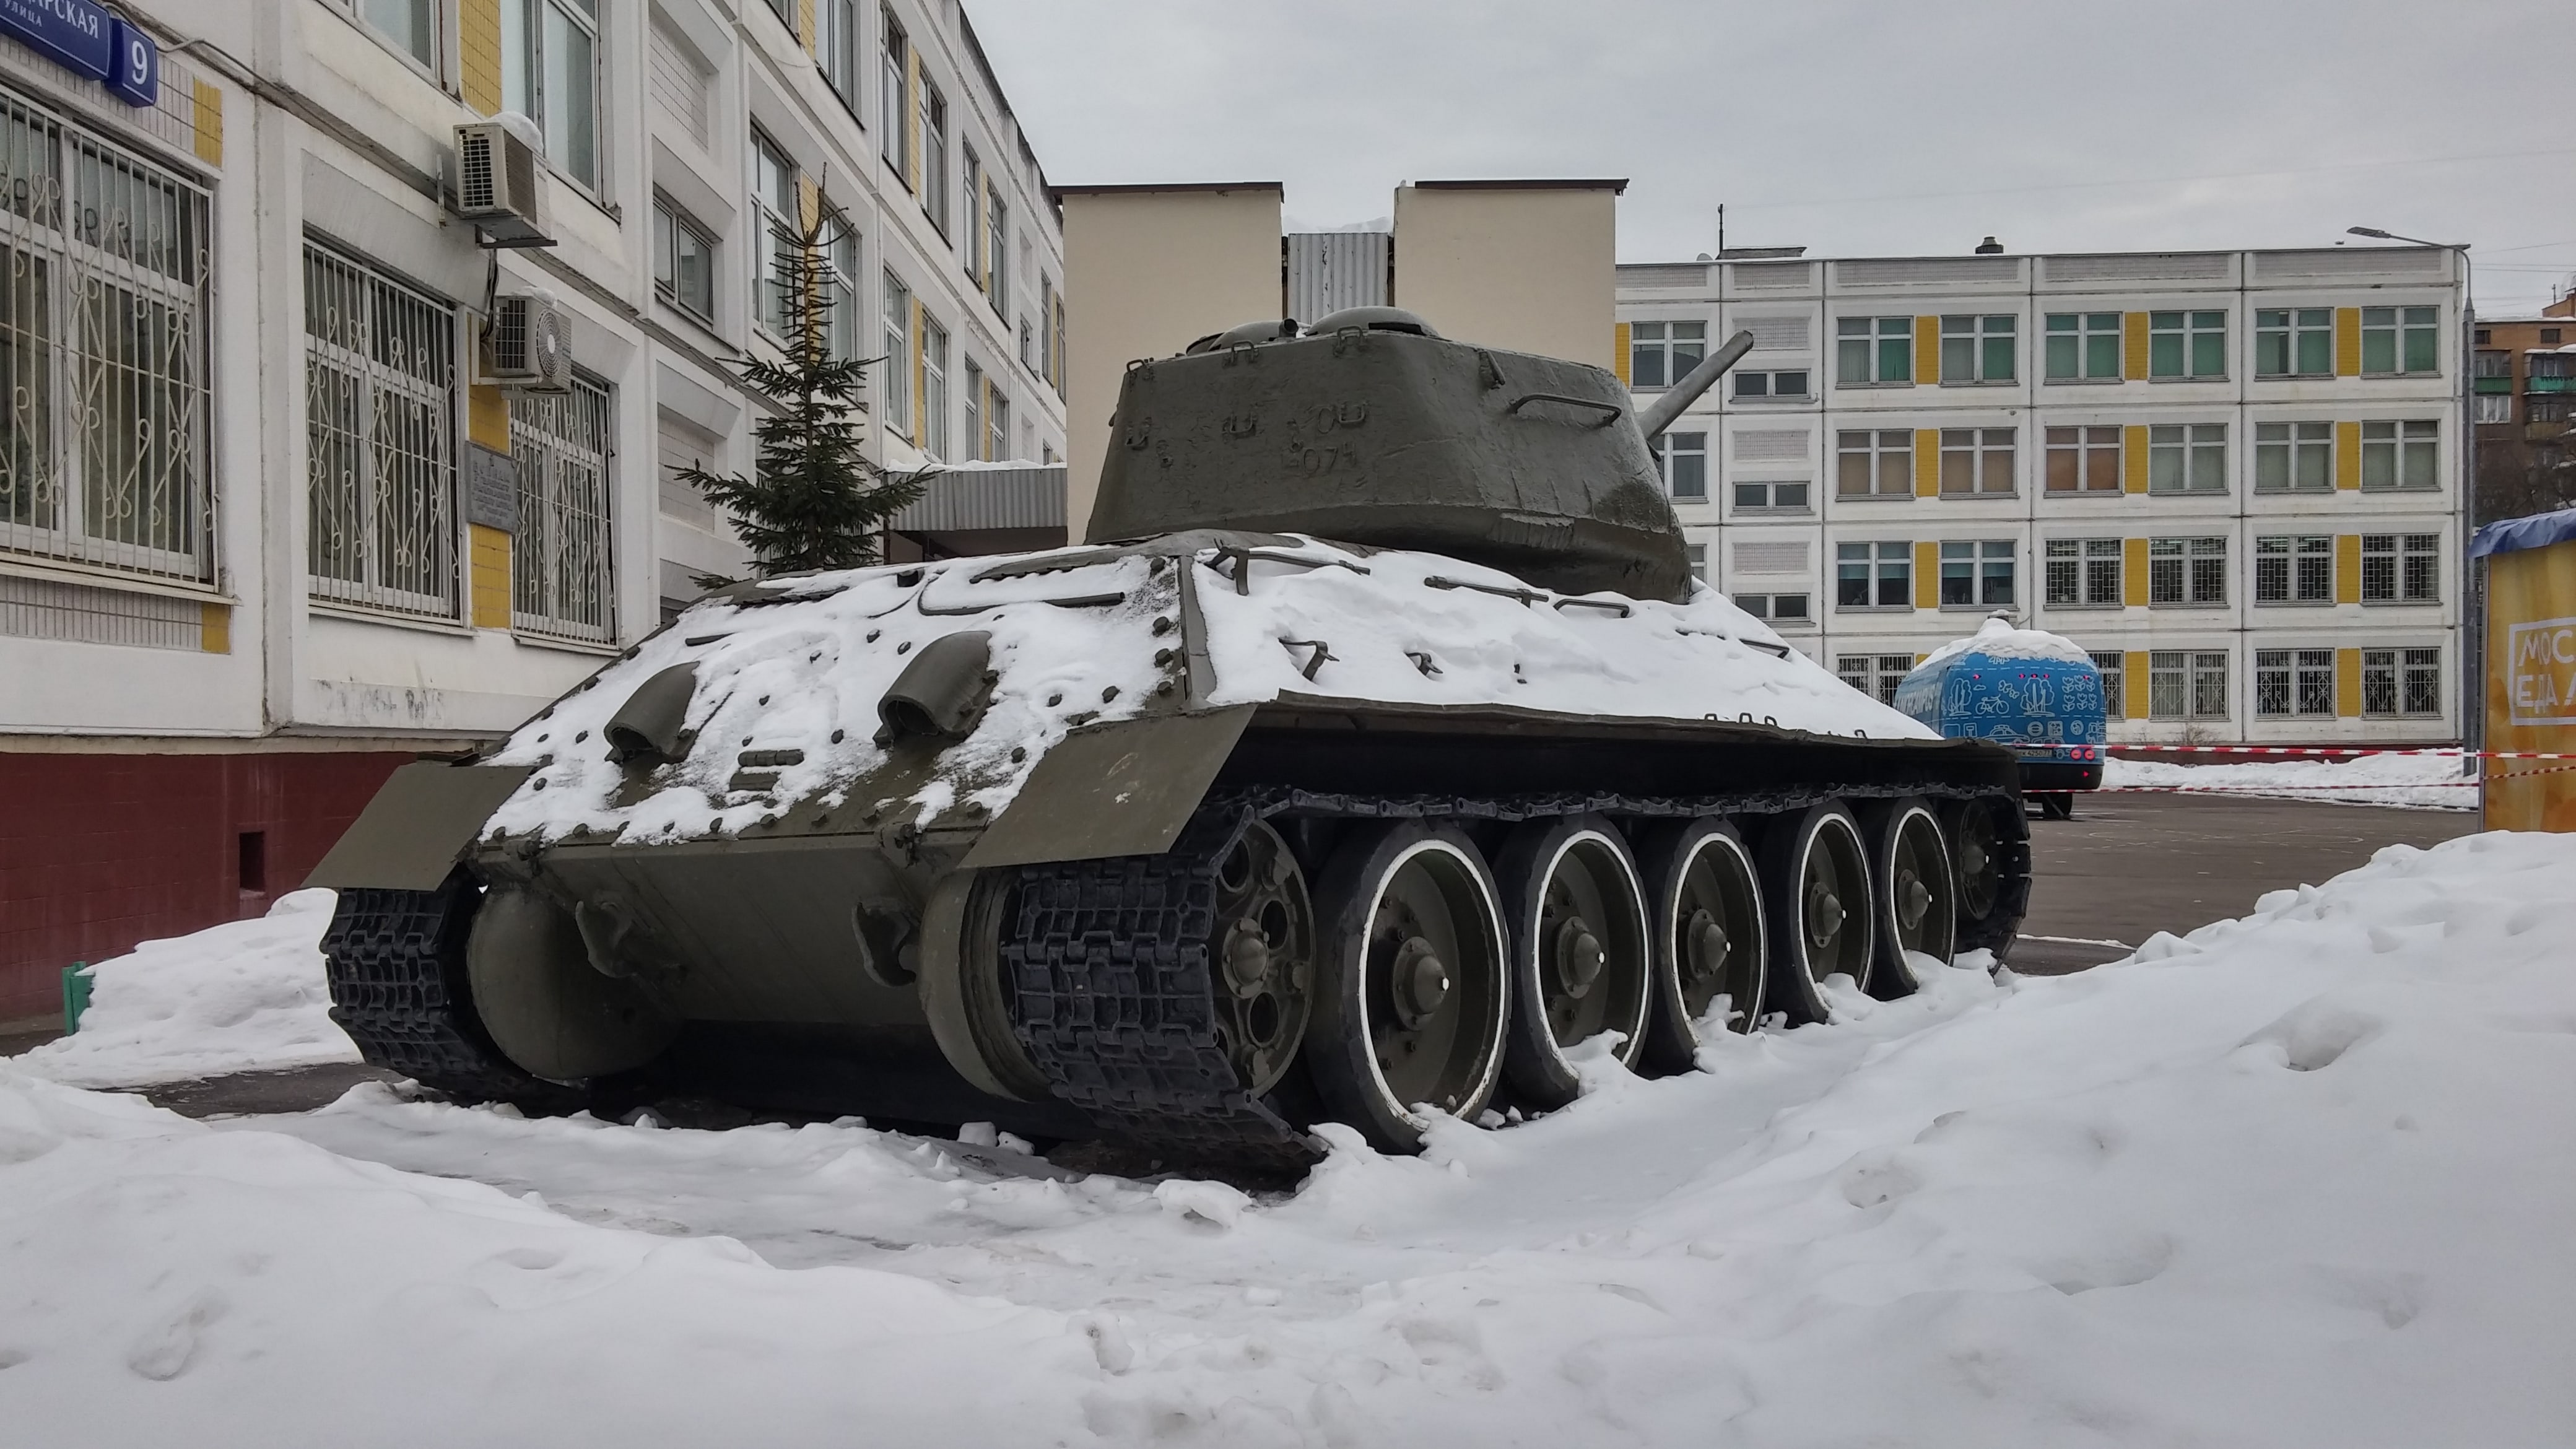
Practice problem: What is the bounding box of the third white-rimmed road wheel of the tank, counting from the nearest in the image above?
[1638,820,1767,1073]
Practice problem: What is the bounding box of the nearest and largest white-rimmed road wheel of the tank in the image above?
[1306,820,1512,1152]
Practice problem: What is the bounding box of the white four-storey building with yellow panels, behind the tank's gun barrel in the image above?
[1617,248,2465,742]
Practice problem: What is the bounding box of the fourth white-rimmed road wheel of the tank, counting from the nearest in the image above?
[1762,802,1878,1021]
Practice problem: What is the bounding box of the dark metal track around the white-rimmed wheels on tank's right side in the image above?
[1002,784,2030,1170]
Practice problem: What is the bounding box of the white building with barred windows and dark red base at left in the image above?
[0,0,1064,1019]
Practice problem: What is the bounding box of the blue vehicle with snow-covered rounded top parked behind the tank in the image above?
[1896,619,2107,820]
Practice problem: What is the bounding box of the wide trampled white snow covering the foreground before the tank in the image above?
[0,835,2576,1449]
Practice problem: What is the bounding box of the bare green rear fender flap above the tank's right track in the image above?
[964,704,1255,869]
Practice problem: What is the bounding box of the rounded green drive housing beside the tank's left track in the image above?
[466,884,680,1086]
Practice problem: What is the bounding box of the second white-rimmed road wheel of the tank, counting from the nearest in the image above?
[1494,815,1654,1108]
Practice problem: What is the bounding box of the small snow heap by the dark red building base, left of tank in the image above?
[18,889,358,1086]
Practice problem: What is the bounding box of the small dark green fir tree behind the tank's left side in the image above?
[680,204,935,588]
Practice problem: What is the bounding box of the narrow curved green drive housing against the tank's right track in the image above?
[920,869,1056,1101]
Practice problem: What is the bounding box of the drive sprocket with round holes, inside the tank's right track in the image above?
[1208,820,1316,1096]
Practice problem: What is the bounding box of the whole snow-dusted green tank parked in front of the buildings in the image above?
[315,310,2030,1170]
